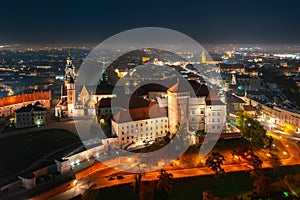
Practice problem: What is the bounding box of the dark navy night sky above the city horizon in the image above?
[0,0,300,43]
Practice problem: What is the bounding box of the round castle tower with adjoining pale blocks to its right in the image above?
[168,81,226,134]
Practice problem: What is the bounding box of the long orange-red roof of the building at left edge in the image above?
[0,91,51,106]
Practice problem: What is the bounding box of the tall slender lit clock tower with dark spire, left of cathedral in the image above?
[65,55,75,117]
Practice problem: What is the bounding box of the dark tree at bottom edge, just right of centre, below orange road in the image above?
[154,169,174,199]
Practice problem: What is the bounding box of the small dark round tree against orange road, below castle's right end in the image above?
[205,152,225,177]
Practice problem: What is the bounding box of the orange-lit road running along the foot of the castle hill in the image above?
[46,131,300,200]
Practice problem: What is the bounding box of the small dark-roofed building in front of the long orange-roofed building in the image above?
[15,103,46,128]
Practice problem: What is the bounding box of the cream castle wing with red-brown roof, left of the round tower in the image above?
[111,103,169,149]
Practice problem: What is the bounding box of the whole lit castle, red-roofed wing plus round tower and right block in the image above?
[111,81,226,149]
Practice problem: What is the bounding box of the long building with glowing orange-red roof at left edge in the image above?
[0,91,51,117]
